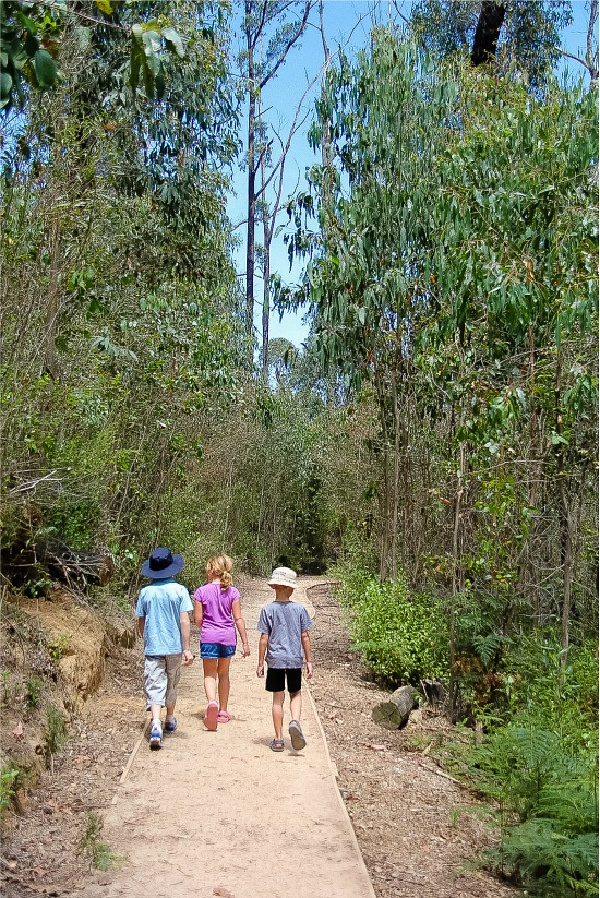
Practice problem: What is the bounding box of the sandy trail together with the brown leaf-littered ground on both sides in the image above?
[0,577,516,898]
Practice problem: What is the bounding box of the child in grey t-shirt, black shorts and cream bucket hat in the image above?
[256,567,312,751]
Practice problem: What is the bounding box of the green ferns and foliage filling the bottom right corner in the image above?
[438,633,598,898]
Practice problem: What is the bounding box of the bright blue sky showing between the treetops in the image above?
[229,0,588,346]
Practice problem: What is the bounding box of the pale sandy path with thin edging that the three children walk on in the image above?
[77,578,374,898]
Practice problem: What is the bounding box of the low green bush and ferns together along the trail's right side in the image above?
[330,559,599,898]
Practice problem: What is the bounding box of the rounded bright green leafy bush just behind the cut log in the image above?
[338,571,448,686]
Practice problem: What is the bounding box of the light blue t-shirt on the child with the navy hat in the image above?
[135,578,194,655]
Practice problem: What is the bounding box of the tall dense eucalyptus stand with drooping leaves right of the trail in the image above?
[286,32,597,656]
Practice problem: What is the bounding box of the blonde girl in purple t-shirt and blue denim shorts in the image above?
[194,555,250,730]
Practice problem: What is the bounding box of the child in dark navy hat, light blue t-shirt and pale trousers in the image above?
[135,548,194,750]
